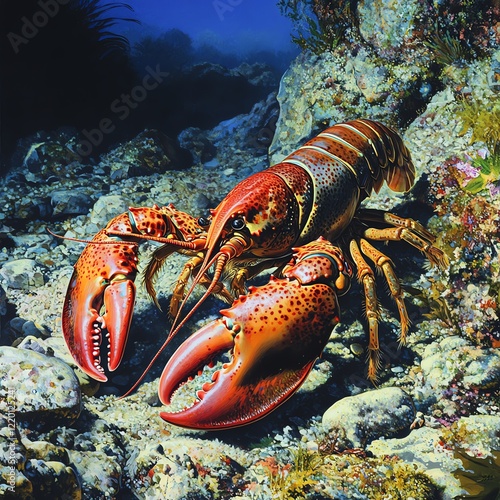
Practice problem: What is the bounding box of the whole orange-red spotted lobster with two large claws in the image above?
[62,120,447,429]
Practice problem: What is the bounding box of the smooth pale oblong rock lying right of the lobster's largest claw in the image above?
[323,387,416,450]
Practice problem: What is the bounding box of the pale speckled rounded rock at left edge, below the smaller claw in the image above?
[0,347,82,429]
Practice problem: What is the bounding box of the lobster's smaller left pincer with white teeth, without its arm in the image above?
[62,233,137,382]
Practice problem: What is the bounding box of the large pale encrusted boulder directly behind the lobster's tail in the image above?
[269,47,429,163]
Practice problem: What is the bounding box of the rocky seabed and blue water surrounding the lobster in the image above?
[0,0,500,499]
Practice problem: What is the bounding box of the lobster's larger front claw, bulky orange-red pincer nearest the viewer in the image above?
[159,278,339,429]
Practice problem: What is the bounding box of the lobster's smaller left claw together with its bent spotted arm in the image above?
[62,205,189,382]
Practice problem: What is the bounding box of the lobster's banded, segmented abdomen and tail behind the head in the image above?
[267,120,415,243]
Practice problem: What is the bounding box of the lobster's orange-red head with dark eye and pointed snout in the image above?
[167,171,300,336]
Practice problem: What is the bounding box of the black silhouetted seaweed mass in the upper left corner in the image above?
[0,0,139,157]
